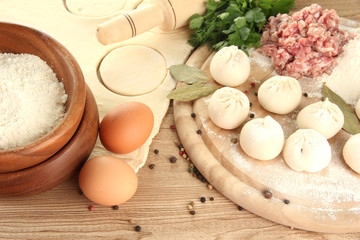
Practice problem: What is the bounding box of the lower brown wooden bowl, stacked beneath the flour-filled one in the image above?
[0,87,99,196]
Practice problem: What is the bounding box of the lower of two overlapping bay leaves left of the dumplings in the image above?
[167,83,219,101]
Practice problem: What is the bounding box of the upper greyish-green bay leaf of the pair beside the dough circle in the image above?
[169,64,209,84]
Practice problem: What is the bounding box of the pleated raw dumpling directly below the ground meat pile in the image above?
[258,76,302,114]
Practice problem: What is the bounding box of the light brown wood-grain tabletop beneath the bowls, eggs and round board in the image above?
[0,0,360,240]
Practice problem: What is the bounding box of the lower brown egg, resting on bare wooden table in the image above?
[79,155,138,206]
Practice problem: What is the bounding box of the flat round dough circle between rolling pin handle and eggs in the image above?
[99,45,167,96]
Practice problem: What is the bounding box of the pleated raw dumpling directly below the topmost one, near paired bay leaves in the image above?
[208,87,250,129]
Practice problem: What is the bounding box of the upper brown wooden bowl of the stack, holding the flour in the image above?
[0,22,86,173]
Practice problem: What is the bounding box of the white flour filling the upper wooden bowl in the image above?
[0,53,67,150]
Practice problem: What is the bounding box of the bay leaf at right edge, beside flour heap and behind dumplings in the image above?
[323,83,360,134]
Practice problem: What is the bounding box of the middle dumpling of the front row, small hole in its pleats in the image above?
[283,129,331,172]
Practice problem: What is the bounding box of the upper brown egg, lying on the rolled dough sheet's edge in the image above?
[99,102,154,154]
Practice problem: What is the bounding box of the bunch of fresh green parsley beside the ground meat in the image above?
[188,0,295,52]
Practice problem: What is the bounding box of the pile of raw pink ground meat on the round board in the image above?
[260,4,352,79]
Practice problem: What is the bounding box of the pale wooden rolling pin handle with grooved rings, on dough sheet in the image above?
[96,4,165,45]
